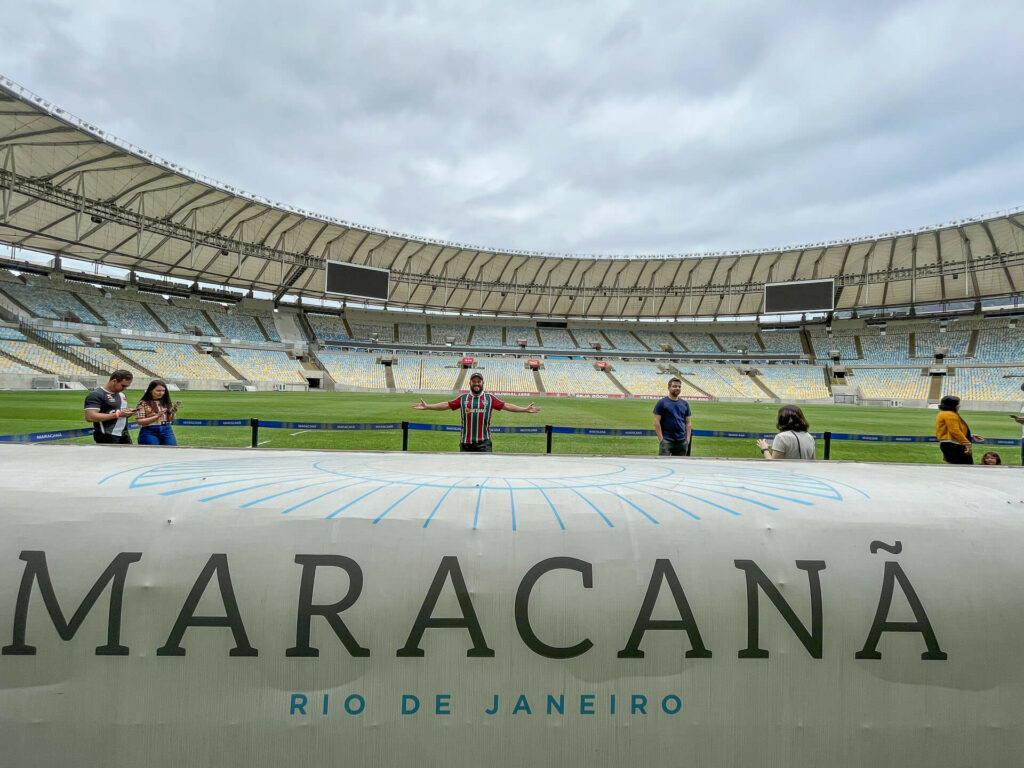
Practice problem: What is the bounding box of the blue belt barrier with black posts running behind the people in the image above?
[0,419,1021,459]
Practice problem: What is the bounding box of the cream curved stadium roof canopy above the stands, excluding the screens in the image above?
[0,78,1024,318]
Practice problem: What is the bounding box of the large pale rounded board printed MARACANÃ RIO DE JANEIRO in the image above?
[0,445,1024,768]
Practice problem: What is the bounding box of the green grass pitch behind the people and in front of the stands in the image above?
[0,391,1020,465]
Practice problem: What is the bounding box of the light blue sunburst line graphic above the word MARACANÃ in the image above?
[100,454,867,530]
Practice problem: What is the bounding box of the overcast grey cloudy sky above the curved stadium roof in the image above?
[0,0,1024,254]
